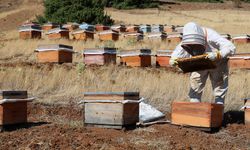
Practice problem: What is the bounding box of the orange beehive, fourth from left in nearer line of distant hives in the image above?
[98,30,119,41]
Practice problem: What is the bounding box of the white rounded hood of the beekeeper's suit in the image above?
[182,22,206,47]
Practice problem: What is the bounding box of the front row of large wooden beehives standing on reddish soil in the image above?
[0,91,250,131]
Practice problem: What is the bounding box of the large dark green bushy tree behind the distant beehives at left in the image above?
[40,0,114,25]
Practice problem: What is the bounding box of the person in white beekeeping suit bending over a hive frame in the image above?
[169,22,235,104]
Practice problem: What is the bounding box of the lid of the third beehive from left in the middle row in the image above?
[119,49,151,57]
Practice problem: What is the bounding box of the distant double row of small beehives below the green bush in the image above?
[19,23,250,44]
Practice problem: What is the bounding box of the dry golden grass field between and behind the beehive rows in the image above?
[0,2,250,112]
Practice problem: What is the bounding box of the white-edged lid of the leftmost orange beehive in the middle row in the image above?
[35,44,74,52]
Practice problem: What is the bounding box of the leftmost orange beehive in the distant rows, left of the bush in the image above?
[19,25,42,40]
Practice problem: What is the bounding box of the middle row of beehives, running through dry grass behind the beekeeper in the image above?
[35,44,250,68]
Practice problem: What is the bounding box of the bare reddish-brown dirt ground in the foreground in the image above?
[0,103,250,150]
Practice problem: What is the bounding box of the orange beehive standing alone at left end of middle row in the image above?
[35,44,74,63]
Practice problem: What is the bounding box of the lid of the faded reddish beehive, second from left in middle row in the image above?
[83,47,117,54]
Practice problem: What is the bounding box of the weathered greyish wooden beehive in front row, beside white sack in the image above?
[84,92,139,129]
